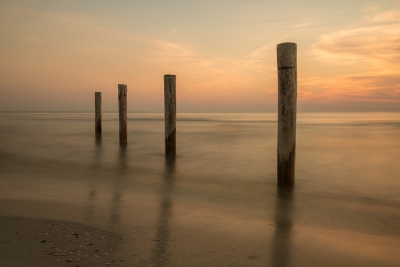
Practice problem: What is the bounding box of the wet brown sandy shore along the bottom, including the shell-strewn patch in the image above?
[0,195,400,267]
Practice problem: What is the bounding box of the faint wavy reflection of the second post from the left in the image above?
[110,144,127,226]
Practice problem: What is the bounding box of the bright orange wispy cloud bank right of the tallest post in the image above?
[299,8,400,103]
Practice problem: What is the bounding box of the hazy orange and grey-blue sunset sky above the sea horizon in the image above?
[0,0,400,112]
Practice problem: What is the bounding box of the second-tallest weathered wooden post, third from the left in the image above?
[164,74,176,157]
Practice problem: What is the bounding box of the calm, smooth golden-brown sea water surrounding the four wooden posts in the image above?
[0,113,400,266]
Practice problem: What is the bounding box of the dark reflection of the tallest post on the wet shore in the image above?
[272,187,293,267]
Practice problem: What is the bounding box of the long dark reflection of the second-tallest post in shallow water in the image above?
[150,157,175,266]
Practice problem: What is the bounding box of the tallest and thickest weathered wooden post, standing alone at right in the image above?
[277,43,297,187]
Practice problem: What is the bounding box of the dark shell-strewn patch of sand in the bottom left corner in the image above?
[0,217,129,267]
